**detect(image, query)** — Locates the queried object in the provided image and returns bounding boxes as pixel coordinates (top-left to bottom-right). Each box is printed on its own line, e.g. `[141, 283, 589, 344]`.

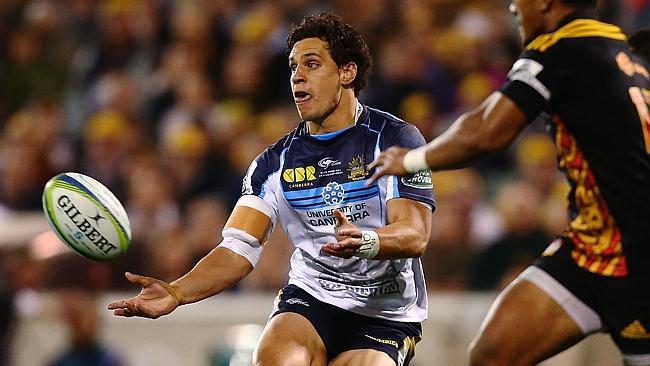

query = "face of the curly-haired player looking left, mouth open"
[289, 38, 342, 122]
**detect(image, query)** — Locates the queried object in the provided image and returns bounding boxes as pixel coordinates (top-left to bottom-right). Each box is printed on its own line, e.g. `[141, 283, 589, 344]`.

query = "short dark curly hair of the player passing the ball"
[286, 13, 373, 96]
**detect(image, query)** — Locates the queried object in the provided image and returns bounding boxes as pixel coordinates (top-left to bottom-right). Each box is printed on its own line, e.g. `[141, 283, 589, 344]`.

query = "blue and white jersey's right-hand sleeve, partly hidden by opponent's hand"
[384, 124, 436, 210]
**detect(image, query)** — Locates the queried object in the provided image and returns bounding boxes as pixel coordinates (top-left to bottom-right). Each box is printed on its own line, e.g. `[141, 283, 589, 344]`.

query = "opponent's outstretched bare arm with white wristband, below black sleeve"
[368, 92, 528, 185]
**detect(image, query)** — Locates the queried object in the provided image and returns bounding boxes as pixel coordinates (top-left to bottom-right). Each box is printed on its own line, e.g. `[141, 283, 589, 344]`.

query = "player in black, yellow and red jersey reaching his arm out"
[370, 0, 650, 366]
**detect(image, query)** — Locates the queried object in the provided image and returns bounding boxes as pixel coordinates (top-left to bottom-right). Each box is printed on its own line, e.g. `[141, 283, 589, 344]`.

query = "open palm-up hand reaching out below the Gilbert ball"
[107, 272, 180, 319]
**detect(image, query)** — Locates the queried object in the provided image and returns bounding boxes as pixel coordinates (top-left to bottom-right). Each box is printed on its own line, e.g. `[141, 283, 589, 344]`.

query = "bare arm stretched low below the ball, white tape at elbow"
[108, 206, 272, 319]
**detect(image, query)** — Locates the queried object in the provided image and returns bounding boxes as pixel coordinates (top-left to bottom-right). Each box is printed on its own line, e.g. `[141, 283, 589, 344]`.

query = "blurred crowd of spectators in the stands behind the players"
[0, 0, 650, 334]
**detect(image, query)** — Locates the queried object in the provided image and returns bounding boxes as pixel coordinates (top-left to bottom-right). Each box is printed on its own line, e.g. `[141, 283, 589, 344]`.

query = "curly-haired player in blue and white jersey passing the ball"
[108, 14, 434, 366]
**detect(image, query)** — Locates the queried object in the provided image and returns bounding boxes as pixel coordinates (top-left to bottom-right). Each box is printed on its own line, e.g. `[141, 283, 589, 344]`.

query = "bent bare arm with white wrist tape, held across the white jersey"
[321, 198, 431, 259]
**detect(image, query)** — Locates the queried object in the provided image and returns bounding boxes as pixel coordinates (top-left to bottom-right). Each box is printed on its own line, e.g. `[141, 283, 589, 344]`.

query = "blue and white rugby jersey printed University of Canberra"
[243, 103, 435, 322]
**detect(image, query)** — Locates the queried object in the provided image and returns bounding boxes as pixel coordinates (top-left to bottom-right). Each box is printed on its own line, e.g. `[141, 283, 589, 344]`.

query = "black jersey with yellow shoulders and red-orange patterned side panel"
[501, 12, 650, 277]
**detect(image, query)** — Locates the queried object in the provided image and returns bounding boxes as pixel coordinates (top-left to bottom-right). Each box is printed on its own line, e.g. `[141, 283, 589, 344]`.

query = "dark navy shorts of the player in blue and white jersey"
[271, 285, 422, 366]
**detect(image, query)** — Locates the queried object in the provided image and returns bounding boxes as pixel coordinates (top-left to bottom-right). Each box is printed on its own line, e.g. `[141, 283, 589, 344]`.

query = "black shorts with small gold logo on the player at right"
[535, 239, 650, 358]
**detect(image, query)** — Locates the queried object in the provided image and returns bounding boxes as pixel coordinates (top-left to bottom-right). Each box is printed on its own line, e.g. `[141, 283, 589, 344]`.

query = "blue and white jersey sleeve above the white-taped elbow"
[242, 150, 280, 225]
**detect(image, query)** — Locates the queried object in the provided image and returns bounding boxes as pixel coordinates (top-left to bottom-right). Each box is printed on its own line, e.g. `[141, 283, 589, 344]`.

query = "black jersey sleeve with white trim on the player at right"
[500, 45, 570, 121]
